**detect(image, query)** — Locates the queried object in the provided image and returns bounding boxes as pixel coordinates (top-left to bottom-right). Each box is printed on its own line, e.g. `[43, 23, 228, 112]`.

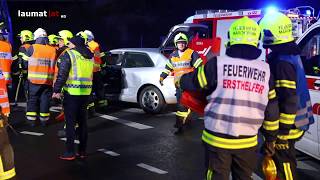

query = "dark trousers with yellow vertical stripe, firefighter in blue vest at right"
[272, 140, 298, 180]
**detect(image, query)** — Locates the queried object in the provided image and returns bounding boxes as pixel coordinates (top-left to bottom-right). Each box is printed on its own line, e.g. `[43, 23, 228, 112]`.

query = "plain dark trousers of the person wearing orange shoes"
[63, 93, 89, 153]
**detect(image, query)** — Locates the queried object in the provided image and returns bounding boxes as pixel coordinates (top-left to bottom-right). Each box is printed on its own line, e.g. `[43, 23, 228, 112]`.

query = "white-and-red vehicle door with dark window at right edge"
[297, 27, 320, 157]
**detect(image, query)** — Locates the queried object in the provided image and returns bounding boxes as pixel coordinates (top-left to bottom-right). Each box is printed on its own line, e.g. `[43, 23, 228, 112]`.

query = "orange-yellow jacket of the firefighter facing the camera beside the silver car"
[160, 48, 202, 78]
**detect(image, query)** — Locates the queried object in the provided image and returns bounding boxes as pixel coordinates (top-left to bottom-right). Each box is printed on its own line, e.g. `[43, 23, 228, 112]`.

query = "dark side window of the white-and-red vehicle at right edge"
[299, 28, 320, 76]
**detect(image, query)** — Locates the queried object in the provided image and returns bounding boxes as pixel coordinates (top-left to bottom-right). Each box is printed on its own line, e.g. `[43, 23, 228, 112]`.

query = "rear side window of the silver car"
[122, 52, 154, 68]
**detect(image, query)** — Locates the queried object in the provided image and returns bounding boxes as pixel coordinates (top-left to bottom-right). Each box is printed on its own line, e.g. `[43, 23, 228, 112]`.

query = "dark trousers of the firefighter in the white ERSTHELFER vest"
[205, 144, 258, 180]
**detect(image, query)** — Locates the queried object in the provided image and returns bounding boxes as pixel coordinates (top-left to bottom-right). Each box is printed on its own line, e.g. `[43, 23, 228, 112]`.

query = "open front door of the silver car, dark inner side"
[101, 51, 124, 94]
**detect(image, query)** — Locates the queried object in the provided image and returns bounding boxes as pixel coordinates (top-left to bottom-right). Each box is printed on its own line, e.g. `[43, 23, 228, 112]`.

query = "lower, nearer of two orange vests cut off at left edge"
[0, 71, 10, 116]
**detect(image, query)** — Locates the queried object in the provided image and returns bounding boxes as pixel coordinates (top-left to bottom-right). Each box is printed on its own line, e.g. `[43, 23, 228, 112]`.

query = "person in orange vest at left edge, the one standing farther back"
[0, 31, 13, 102]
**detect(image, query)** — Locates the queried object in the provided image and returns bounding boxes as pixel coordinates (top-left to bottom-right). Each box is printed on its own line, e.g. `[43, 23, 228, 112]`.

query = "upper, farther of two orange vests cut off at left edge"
[0, 41, 13, 84]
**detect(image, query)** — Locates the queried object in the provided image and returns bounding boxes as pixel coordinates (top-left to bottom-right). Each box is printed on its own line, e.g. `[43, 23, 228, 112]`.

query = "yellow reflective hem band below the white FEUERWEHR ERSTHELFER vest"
[202, 130, 258, 149]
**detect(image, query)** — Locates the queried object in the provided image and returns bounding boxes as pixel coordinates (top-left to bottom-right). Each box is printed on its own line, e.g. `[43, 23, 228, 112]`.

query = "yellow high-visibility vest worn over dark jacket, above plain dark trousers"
[63, 50, 94, 96]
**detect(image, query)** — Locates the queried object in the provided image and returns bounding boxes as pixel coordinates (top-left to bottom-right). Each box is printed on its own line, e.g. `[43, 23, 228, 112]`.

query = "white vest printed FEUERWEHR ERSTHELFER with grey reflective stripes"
[205, 57, 270, 137]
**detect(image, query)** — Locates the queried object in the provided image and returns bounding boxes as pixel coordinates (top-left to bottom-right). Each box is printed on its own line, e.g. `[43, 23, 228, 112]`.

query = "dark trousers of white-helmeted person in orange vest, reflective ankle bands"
[27, 83, 52, 121]
